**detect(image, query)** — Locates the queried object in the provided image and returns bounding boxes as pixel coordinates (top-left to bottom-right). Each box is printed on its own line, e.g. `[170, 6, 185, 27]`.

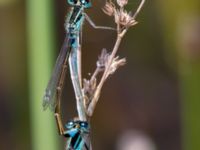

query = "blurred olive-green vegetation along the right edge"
[158, 0, 200, 150]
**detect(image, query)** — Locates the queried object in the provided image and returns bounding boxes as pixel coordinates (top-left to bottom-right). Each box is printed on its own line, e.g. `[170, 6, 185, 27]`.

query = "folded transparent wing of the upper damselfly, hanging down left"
[43, 36, 70, 110]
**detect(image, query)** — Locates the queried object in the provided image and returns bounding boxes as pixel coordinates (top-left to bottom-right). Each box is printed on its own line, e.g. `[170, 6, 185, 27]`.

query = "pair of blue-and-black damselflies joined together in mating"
[43, 0, 113, 150]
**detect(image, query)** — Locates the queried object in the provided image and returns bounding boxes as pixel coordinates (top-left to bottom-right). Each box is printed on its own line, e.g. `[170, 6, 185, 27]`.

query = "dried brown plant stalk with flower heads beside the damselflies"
[83, 0, 145, 117]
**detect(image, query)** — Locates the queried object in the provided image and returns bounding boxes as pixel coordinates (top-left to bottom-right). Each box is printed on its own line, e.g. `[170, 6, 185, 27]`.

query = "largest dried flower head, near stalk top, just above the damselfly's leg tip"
[115, 10, 137, 27]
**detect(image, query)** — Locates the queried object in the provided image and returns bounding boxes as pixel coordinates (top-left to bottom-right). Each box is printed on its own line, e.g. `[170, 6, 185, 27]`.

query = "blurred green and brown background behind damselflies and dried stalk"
[0, 0, 200, 150]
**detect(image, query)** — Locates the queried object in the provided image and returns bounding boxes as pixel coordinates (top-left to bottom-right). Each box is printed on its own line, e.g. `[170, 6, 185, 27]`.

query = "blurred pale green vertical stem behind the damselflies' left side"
[27, 0, 58, 150]
